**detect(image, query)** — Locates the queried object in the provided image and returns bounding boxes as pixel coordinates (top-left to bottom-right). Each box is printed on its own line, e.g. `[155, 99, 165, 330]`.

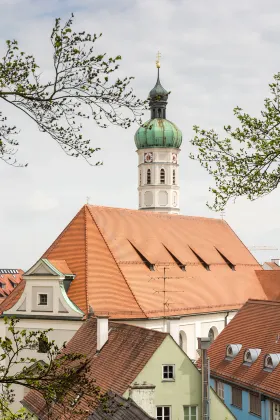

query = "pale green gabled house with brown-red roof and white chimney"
[23, 317, 235, 420]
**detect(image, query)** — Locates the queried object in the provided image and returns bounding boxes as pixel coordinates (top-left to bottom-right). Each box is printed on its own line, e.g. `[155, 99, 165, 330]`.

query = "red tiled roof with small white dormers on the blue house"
[208, 300, 280, 399]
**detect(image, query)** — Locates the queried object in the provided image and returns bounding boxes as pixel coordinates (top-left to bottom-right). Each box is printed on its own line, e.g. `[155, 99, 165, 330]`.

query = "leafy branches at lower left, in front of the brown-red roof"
[0, 318, 108, 420]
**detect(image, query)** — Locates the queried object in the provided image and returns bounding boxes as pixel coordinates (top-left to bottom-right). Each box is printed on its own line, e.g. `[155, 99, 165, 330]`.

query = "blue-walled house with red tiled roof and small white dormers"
[208, 300, 280, 420]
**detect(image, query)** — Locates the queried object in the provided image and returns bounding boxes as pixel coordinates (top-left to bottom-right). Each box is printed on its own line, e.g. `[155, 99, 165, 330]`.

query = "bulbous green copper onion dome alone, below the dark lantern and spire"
[134, 118, 182, 149]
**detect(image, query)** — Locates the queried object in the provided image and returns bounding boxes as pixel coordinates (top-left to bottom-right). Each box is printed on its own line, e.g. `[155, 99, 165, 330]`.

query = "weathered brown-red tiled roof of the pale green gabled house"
[23, 318, 167, 418]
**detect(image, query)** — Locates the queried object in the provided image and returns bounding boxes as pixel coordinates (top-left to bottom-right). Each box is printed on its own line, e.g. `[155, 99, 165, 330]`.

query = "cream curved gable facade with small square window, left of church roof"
[0, 259, 84, 411]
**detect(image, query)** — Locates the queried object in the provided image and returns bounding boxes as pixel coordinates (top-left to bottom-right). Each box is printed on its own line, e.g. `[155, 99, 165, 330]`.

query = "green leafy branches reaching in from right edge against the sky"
[191, 73, 280, 211]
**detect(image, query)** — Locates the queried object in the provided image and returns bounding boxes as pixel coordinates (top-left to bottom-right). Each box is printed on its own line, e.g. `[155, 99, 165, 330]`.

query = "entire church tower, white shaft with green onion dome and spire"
[135, 60, 182, 214]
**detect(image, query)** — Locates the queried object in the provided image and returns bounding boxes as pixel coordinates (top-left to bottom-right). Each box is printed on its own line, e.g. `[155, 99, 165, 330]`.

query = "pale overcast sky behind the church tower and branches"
[0, 0, 280, 269]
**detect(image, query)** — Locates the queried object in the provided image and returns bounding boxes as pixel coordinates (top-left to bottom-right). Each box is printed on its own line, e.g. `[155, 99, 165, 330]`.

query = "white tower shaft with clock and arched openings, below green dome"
[137, 147, 180, 214]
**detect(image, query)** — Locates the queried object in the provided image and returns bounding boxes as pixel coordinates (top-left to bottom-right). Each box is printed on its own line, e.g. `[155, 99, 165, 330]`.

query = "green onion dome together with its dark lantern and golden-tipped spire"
[134, 61, 182, 149]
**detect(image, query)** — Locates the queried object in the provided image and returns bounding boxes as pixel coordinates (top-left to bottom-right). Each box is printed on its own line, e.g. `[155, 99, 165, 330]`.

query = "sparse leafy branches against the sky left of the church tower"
[0, 15, 144, 165]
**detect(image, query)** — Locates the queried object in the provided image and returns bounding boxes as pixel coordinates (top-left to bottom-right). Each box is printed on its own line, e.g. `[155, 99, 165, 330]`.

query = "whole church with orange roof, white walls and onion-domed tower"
[0, 62, 267, 368]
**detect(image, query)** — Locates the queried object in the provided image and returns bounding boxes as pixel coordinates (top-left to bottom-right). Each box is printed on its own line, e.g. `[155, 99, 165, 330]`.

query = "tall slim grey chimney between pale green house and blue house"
[197, 337, 211, 420]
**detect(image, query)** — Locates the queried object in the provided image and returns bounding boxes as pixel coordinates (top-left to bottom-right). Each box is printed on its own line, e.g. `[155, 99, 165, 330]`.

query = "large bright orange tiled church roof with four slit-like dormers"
[44, 205, 266, 319]
